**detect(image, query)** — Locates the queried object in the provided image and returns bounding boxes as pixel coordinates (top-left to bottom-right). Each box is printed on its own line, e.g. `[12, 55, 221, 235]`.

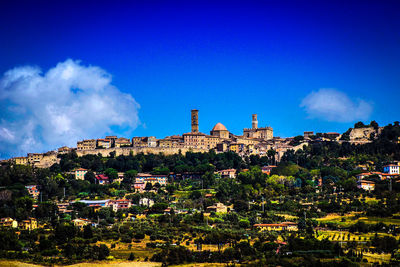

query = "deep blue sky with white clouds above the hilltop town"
[0, 0, 400, 158]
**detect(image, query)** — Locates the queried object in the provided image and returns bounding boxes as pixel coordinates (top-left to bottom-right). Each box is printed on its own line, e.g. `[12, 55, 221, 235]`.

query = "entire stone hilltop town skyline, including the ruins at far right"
[11, 109, 382, 168]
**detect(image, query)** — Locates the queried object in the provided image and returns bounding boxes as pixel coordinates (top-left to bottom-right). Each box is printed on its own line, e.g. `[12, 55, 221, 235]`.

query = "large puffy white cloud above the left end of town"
[0, 59, 139, 158]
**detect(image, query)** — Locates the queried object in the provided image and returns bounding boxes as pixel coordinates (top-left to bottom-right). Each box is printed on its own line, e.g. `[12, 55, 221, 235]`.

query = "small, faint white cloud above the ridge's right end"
[300, 88, 372, 122]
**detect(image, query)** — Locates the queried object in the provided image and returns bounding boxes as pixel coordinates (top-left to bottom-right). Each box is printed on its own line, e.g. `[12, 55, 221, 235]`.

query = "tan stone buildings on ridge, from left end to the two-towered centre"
[12, 110, 279, 168]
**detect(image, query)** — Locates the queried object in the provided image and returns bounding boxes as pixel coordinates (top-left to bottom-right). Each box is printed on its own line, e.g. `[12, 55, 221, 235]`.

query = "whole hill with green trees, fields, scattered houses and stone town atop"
[0, 110, 400, 266]
